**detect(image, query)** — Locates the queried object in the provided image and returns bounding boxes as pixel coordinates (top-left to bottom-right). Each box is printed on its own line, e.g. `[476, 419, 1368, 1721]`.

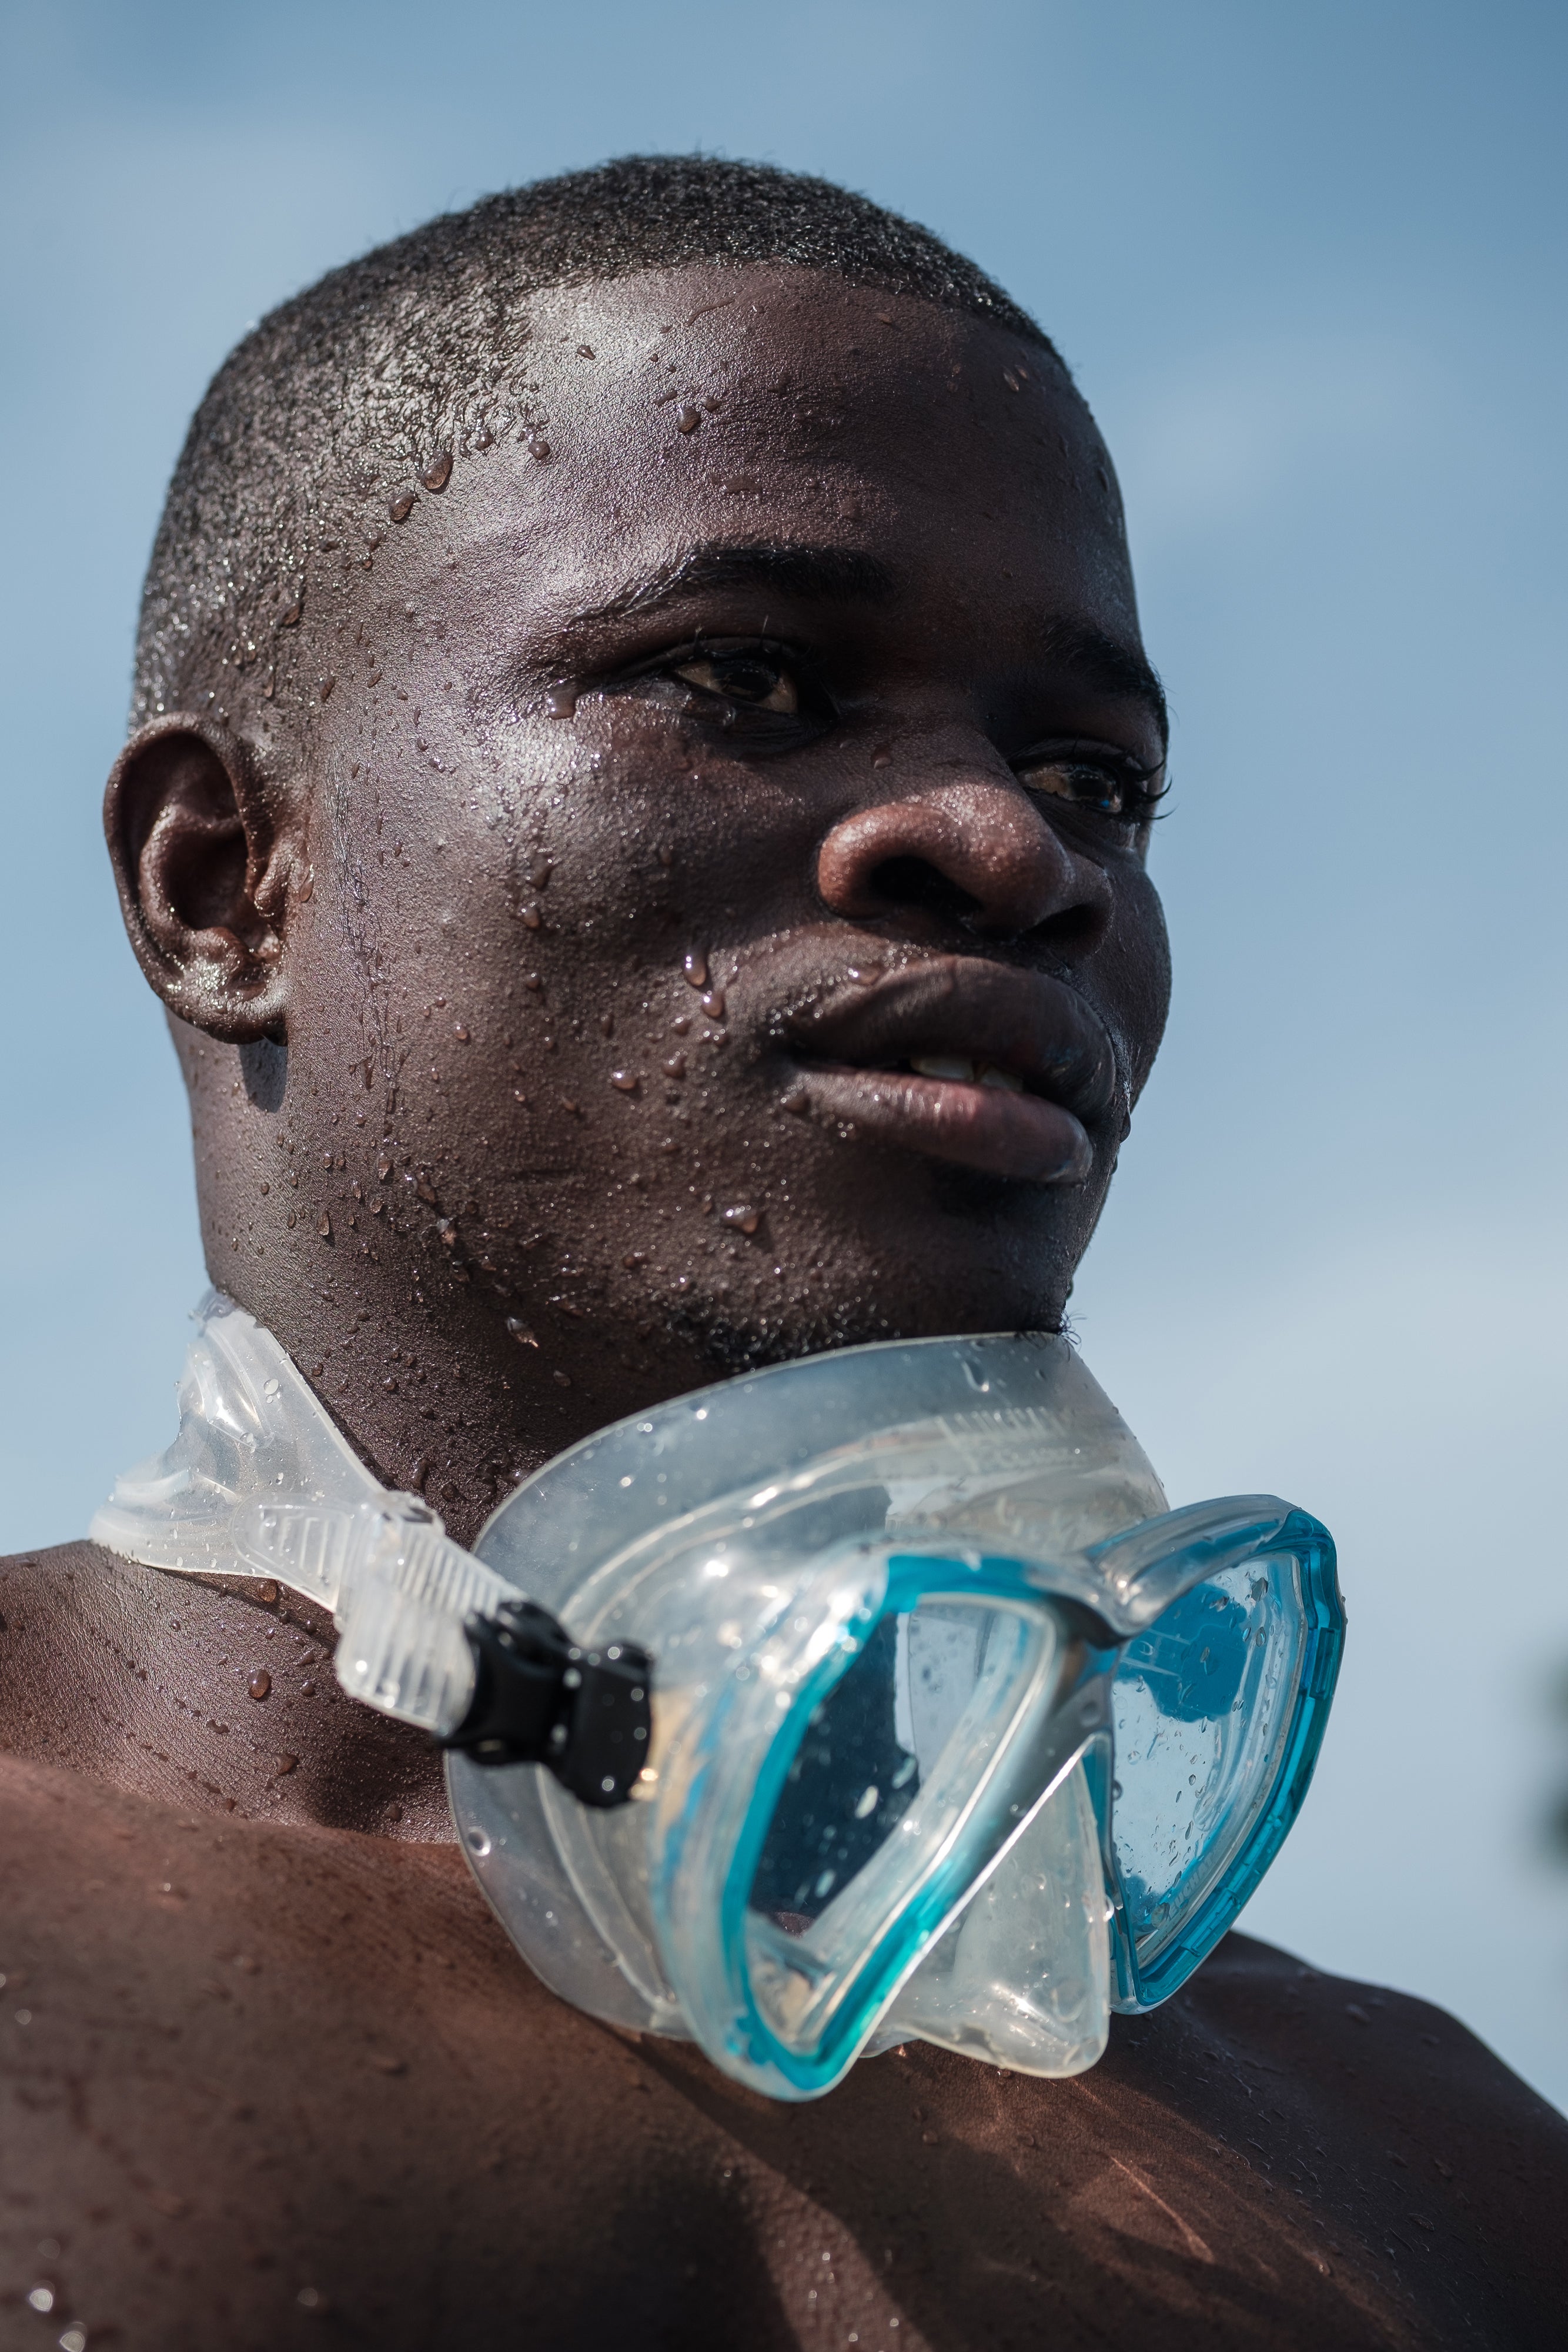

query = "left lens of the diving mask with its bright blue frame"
[654, 1557, 1102, 2098]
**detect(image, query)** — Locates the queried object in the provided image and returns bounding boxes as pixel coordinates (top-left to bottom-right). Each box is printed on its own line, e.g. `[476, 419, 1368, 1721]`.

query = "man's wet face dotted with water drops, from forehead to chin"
[289, 268, 1168, 1411]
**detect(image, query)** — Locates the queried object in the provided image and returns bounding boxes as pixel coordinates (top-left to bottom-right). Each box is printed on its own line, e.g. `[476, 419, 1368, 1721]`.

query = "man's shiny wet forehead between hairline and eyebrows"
[380, 266, 1135, 637]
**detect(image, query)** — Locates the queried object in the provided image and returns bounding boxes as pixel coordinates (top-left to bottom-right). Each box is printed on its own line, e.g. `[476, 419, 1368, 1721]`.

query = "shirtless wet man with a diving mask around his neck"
[0, 160, 1568, 2352]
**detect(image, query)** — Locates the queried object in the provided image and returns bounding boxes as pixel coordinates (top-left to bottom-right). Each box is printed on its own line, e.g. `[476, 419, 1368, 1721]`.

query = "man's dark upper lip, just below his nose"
[787, 955, 1121, 1127]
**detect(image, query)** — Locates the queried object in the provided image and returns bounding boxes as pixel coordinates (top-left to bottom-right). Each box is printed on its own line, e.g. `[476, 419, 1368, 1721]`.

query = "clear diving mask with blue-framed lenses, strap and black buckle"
[92, 1298, 1345, 2098]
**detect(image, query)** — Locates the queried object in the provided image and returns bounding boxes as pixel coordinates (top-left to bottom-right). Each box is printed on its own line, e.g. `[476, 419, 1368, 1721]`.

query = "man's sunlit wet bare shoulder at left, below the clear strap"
[0, 1757, 785, 2352]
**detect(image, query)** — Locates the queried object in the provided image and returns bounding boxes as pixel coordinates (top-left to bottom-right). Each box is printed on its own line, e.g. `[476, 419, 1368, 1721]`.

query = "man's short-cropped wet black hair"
[134, 155, 1067, 720]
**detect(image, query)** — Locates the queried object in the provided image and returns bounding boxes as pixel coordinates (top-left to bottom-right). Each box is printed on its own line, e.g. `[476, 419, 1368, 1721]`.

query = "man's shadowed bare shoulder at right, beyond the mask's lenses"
[1100, 1936, 1568, 2347]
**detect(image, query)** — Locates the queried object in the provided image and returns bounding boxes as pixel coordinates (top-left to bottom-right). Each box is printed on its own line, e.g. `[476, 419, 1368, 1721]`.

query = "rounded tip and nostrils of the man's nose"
[815, 769, 1112, 955]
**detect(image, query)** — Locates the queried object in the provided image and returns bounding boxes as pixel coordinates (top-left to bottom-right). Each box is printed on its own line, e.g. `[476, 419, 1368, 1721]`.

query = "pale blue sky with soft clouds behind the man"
[0, 0, 1568, 2103]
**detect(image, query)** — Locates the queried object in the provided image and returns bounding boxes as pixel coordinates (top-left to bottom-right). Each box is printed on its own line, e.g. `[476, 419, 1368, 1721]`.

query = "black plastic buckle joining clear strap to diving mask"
[442, 1602, 654, 1806]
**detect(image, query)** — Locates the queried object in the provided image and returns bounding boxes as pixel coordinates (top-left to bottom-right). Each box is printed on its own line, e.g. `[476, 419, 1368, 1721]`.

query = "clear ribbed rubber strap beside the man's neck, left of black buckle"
[89, 1291, 517, 1736]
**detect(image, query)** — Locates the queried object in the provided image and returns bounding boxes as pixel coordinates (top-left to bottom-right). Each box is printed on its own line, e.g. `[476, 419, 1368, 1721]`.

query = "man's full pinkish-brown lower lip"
[799, 1063, 1093, 1183]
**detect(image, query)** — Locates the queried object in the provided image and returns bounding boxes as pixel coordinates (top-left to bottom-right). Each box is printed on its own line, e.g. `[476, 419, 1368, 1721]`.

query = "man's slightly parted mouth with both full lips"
[790, 955, 1119, 1185]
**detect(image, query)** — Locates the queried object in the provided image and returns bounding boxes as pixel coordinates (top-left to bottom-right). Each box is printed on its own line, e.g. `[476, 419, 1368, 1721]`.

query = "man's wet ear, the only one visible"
[103, 713, 299, 1044]
